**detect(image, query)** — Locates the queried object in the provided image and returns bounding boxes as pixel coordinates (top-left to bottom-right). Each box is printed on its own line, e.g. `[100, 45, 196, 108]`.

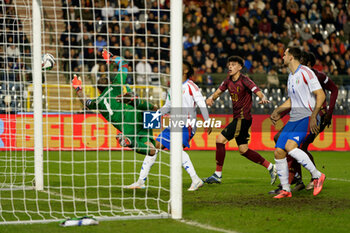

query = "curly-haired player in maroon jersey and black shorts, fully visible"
[204, 56, 277, 184]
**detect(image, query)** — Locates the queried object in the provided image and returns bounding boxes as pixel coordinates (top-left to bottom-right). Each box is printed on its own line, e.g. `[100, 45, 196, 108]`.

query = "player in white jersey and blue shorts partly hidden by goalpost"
[125, 62, 211, 191]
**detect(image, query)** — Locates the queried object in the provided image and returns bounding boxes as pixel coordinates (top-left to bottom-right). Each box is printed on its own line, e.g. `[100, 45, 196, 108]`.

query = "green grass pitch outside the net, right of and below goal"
[0, 151, 350, 233]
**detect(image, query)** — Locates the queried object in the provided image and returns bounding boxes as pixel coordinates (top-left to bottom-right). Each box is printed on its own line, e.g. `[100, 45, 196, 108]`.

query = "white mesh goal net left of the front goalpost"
[0, 0, 180, 224]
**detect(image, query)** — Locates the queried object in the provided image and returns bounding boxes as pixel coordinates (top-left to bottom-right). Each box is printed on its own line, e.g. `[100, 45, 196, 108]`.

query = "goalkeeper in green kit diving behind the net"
[72, 51, 157, 156]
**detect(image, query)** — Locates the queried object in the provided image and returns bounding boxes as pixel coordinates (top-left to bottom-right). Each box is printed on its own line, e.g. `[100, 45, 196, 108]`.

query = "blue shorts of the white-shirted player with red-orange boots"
[275, 117, 310, 150]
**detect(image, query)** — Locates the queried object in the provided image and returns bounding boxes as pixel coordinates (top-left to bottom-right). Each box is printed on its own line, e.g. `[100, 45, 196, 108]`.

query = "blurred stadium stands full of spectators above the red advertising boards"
[0, 0, 350, 114]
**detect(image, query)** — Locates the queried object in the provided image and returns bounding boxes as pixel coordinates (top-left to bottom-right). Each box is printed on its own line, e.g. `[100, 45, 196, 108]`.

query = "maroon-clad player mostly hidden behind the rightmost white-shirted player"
[269, 52, 338, 194]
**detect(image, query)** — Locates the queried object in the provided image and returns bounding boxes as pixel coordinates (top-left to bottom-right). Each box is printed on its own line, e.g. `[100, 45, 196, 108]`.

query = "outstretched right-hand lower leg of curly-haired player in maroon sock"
[238, 144, 277, 185]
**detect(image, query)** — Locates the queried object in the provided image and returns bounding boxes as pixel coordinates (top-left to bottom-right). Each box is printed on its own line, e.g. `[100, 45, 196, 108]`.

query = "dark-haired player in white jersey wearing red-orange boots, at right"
[271, 47, 326, 198]
